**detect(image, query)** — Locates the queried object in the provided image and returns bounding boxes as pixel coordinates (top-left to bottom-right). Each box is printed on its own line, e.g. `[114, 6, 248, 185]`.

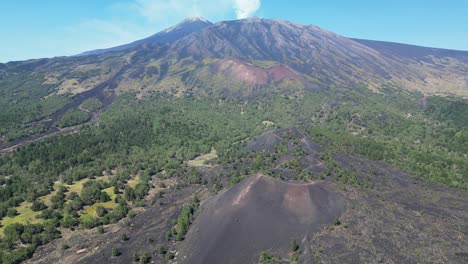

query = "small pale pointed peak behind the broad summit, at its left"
[80, 17, 212, 56]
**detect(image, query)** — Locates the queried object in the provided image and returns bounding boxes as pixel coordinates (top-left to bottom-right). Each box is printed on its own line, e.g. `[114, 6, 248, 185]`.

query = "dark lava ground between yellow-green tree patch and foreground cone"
[27, 183, 202, 264]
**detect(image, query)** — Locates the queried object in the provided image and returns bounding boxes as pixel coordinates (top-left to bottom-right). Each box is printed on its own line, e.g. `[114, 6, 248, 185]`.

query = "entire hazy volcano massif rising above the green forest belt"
[0, 17, 468, 100]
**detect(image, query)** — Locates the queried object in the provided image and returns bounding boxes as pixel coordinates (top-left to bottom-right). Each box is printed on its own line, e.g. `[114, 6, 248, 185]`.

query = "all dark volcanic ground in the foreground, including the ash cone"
[28, 129, 468, 264]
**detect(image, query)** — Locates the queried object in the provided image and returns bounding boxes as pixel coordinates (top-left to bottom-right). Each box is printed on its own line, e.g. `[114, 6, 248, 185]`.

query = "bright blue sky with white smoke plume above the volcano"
[0, 0, 468, 62]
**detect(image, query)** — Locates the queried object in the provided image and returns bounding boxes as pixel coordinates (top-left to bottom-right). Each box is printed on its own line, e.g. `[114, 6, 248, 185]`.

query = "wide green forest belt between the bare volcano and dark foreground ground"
[0, 85, 468, 263]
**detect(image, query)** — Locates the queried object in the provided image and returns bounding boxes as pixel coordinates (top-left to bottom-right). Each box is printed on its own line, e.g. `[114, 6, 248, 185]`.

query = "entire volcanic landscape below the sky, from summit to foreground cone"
[0, 18, 468, 263]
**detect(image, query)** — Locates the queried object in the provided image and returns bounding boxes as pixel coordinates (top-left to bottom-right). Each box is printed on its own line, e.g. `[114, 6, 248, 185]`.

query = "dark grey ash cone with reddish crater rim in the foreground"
[179, 175, 345, 264]
